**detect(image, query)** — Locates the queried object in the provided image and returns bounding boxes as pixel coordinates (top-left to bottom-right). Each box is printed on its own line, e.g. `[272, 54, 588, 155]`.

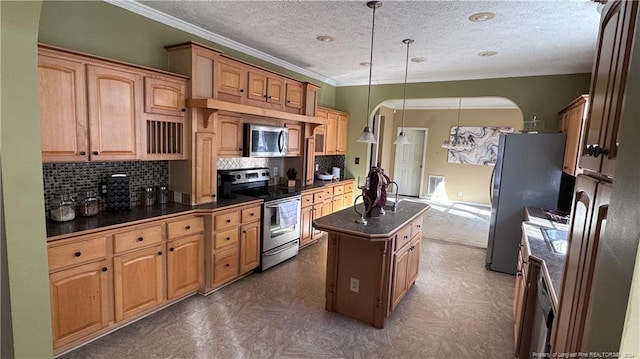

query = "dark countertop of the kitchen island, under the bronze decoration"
[313, 201, 431, 241]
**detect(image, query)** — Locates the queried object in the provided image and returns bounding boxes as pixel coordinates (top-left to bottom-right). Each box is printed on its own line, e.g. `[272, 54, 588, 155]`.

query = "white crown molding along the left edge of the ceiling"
[103, 0, 337, 86]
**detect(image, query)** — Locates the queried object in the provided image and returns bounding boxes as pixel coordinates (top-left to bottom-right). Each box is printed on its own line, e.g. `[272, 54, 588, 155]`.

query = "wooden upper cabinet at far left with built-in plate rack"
[38, 45, 186, 163]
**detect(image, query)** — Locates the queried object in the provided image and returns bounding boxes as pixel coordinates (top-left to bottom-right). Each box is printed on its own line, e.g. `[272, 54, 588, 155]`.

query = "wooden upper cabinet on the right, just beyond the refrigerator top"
[560, 95, 589, 176]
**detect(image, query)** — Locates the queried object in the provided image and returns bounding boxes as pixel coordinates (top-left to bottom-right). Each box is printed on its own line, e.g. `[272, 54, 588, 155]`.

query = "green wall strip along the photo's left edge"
[0, 1, 53, 358]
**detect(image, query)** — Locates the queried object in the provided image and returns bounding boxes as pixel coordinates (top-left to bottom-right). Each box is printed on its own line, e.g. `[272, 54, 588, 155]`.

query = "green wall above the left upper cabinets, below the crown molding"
[38, 1, 335, 107]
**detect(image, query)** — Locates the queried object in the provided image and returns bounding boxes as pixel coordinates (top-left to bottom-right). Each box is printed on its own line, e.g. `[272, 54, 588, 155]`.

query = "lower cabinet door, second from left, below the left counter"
[113, 245, 164, 322]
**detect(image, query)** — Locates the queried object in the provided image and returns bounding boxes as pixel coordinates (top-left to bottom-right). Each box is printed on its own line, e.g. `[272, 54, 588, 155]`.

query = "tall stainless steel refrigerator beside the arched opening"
[486, 133, 566, 274]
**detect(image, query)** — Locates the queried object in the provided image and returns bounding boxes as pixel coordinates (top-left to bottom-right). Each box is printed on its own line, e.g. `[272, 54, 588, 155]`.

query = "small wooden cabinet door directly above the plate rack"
[144, 77, 186, 117]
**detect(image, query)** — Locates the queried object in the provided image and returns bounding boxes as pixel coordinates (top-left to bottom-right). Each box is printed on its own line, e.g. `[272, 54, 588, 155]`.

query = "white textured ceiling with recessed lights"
[120, 0, 600, 86]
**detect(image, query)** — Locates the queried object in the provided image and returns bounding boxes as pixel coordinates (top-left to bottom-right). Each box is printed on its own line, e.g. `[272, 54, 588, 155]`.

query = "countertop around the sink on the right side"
[522, 207, 569, 313]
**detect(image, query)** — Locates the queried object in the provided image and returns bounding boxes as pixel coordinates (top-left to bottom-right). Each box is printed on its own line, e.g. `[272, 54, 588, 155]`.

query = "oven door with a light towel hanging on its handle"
[262, 196, 300, 252]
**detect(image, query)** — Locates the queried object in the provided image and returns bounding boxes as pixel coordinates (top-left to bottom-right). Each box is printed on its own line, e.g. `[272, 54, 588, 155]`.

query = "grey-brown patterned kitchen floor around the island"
[62, 204, 514, 359]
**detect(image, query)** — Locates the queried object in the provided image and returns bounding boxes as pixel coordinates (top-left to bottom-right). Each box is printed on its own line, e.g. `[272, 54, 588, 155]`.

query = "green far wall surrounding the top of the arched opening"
[336, 74, 591, 177]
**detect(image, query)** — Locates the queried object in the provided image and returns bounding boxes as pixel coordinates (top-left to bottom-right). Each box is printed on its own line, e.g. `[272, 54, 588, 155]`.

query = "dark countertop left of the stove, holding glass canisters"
[46, 195, 262, 241]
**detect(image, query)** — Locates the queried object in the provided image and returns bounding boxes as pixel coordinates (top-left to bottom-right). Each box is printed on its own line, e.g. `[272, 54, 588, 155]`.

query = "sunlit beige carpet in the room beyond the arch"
[402, 197, 491, 248]
